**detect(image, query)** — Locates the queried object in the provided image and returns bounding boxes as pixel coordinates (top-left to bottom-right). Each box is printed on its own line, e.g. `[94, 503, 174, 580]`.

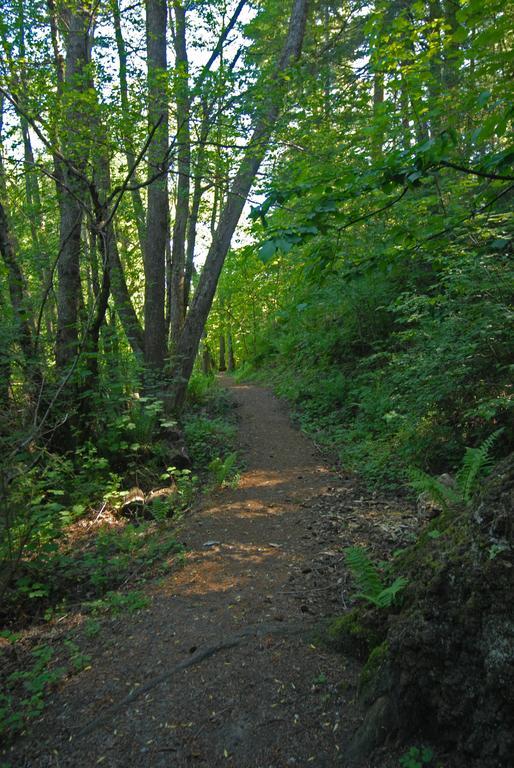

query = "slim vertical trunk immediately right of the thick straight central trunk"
[170, 2, 191, 344]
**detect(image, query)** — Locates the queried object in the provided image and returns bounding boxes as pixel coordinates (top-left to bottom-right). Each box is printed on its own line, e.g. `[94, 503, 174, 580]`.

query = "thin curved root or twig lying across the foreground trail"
[70, 621, 322, 739]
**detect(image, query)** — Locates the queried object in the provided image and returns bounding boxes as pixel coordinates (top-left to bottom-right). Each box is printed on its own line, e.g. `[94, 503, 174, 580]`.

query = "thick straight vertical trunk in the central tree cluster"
[145, 0, 168, 371]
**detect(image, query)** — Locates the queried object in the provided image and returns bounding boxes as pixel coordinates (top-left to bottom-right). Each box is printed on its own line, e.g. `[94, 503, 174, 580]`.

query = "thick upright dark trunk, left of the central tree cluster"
[56, 4, 92, 368]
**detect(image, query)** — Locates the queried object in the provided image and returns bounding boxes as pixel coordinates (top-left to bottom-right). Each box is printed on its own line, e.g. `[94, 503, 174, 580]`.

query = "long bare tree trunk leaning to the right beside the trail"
[169, 0, 309, 410]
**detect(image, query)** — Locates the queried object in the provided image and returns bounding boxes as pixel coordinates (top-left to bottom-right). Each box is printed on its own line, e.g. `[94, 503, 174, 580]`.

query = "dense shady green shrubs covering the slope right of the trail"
[234, 243, 514, 493]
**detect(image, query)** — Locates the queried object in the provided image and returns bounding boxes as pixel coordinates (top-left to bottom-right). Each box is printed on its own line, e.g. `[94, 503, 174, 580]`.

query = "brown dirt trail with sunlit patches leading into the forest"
[6, 379, 368, 768]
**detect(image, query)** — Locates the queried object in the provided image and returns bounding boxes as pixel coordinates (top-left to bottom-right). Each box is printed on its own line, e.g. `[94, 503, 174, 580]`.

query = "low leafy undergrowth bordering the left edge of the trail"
[0, 373, 237, 741]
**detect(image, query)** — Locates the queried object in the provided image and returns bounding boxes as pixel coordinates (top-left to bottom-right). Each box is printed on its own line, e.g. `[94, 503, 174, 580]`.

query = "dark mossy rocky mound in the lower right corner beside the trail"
[346, 457, 514, 768]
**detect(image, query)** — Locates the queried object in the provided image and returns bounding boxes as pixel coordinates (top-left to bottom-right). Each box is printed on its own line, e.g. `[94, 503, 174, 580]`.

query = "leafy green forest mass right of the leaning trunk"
[204, 2, 513, 484]
